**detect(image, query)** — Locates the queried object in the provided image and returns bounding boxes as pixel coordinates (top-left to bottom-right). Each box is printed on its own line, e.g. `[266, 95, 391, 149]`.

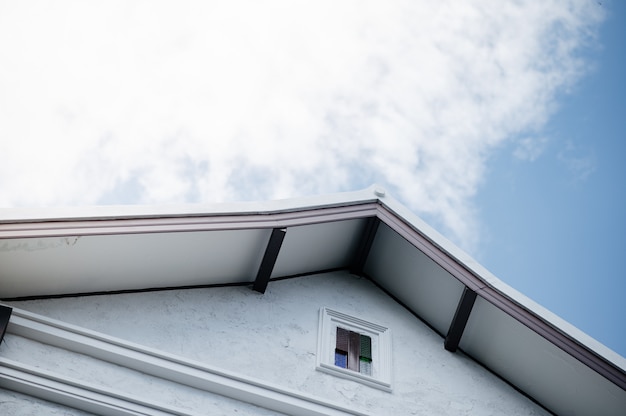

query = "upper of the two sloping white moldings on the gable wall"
[0, 308, 367, 416]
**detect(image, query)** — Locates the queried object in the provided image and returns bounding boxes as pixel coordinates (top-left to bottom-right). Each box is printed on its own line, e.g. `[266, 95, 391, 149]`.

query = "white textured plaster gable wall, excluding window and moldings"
[0, 272, 548, 415]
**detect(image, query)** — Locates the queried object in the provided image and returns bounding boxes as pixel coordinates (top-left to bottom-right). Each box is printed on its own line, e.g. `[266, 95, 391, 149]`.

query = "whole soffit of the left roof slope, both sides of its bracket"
[0, 213, 365, 299]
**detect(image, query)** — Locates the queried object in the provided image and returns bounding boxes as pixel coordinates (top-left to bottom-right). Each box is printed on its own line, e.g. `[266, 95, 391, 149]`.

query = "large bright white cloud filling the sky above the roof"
[0, 0, 601, 247]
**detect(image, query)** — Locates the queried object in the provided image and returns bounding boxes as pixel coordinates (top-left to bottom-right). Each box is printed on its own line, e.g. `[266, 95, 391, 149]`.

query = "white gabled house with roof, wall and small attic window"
[0, 186, 626, 415]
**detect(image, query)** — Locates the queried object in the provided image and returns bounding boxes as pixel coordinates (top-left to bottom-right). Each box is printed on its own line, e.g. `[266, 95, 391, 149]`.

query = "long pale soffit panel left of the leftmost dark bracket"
[0, 229, 270, 298]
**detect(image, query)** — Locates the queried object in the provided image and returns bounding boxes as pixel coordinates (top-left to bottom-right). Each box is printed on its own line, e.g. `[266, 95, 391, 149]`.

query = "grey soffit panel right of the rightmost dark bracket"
[460, 297, 626, 415]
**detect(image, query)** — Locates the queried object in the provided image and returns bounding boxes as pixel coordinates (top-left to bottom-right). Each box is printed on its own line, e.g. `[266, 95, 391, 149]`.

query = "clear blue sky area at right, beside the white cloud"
[476, 1, 626, 356]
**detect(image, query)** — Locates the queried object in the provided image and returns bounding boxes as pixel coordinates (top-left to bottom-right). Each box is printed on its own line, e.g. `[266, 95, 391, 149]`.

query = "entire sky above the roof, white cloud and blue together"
[0, 0, 626, 356]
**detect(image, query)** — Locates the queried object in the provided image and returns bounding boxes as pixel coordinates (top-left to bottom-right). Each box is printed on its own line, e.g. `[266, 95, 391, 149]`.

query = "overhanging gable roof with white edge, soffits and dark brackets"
[0, 185, 626, 414]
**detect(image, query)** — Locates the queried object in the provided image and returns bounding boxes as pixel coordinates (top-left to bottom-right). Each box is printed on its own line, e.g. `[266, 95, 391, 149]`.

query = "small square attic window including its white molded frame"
[317, 308, 391, 391]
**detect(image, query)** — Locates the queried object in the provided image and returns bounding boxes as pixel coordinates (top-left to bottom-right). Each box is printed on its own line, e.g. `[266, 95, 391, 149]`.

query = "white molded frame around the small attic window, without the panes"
[317, 308, 391, 391]
